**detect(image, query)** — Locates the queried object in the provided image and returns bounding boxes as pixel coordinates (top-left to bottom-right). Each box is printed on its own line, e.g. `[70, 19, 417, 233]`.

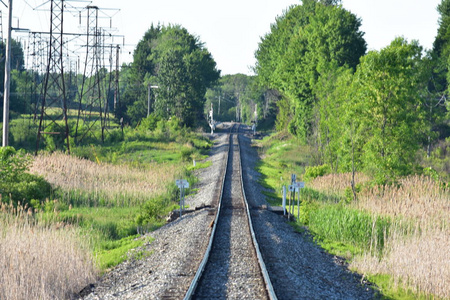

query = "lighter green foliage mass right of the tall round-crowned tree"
[315, 38, 428, 184]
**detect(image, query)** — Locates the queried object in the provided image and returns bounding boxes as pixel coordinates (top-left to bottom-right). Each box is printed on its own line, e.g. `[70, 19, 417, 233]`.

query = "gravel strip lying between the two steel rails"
[193, 135, 268, 299]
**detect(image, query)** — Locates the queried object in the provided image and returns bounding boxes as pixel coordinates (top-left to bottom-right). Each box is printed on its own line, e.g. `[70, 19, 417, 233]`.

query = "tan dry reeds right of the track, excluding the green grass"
[352, 176, 450, 298]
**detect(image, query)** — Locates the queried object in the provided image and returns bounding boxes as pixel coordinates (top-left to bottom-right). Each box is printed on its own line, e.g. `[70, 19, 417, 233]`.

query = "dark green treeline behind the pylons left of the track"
[0, 25, 220, 134]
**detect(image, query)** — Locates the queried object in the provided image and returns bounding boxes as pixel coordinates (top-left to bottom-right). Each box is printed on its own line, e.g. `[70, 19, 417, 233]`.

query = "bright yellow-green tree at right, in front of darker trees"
[349, 38, 427, 183]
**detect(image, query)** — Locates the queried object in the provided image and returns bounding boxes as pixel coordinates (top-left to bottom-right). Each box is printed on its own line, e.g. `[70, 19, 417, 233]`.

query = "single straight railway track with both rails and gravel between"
[184, 124, 276, 299]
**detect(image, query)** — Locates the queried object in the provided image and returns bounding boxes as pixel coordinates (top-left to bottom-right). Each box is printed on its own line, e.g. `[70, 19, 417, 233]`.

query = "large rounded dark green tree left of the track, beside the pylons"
[120, 25, 220, 126]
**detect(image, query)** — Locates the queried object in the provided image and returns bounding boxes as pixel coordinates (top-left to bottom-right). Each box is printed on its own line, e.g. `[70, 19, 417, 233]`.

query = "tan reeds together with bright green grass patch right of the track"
[309, 174, 450, 298]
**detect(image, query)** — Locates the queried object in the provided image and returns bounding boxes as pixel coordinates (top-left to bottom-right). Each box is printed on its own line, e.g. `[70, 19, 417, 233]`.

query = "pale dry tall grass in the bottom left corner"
[0, 204, 96, 300]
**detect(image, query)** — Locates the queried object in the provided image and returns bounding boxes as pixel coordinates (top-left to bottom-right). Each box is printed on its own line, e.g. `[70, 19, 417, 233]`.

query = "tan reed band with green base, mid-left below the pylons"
[30, 152, 181, 206]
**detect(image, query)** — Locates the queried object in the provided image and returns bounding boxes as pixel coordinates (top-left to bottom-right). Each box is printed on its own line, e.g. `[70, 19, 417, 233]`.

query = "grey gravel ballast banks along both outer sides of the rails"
[80, 124, 374, 300]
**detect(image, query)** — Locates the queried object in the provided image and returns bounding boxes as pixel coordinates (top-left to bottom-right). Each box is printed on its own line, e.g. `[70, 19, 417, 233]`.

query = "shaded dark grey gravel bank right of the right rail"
[241, 128, 377, 299]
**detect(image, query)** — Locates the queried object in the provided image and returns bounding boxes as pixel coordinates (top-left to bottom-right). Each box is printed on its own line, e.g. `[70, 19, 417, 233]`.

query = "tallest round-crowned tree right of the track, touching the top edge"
[255, 0, 366, 141]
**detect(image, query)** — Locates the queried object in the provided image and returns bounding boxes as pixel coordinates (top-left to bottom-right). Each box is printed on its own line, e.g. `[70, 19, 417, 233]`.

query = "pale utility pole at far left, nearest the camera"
[2, 0, 12, 147]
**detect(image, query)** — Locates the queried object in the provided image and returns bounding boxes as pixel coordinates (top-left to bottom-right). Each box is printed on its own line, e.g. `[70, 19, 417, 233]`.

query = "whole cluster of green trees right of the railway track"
[255, 0, 450, 183]
